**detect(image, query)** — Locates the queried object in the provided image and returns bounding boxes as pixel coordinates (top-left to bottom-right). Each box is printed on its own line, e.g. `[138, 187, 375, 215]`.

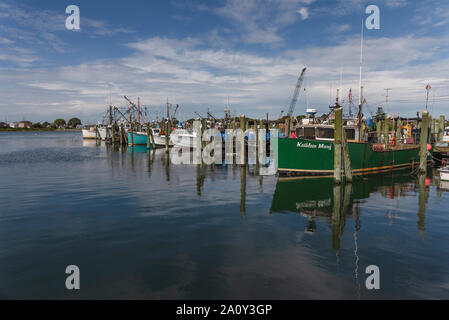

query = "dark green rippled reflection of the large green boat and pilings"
[270, 172, 429, 246]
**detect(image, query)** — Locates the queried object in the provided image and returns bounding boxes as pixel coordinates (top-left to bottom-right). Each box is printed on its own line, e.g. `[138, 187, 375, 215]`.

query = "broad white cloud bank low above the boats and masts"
[0, 32, 449, 120]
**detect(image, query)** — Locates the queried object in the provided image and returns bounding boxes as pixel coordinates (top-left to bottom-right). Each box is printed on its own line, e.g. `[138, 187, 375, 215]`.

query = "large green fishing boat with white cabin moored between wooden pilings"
[278, 124, 430, 175]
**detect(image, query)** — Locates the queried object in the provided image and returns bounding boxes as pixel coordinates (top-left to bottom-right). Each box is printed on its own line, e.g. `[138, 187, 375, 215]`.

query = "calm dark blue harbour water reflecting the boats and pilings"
[0, 133, 449, 299]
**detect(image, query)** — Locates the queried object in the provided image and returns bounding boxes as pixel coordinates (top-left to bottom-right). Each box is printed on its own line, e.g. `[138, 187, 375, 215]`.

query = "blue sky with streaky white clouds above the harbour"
[0, 0, 449, 123]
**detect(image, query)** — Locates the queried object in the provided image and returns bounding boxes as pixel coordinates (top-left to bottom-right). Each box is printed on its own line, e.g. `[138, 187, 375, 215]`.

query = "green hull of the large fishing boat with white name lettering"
[278, 139, 426, 175]
